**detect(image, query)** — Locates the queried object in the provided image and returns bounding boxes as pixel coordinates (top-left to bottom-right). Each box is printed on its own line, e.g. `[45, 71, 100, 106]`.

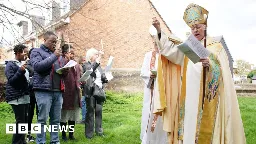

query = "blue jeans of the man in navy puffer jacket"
[35, 91, 63, 144]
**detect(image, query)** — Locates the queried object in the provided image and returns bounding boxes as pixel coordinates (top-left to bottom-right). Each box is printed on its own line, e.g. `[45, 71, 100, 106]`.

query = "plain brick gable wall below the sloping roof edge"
[56, 0, 170, 69]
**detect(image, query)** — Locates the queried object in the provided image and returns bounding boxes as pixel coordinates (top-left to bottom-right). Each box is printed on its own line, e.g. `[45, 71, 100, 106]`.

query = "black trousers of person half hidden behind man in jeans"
[28, 92, 38, 134]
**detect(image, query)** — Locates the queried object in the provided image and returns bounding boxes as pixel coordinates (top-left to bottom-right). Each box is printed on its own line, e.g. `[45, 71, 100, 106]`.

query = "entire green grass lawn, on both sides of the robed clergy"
[0, 92, 256, 144]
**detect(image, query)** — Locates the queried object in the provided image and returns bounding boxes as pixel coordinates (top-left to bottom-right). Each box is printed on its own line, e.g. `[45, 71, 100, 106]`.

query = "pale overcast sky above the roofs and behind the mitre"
[0, 0, 256, 65]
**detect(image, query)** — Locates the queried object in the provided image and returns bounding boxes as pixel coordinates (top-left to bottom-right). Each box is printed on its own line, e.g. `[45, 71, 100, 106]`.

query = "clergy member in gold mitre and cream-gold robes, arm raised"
[153, 4, 246, 144]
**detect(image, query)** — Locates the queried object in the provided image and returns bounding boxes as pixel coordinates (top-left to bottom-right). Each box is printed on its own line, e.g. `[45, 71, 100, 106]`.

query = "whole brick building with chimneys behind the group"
[16, 0, 171, 70]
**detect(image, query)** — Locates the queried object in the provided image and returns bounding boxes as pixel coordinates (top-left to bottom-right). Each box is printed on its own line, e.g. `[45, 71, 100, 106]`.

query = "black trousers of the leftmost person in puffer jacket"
[11, 104, 28, 144]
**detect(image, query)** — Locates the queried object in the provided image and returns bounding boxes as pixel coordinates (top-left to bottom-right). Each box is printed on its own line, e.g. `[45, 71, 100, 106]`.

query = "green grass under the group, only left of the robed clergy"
[0, 92, 142, 144]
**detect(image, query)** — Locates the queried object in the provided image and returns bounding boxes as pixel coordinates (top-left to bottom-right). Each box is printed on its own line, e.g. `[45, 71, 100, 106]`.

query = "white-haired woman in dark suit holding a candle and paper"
[83, 48, 108, 139]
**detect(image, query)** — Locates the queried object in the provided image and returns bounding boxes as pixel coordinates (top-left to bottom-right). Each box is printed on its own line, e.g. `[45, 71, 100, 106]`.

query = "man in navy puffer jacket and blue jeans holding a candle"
[30, 31, 68, 144]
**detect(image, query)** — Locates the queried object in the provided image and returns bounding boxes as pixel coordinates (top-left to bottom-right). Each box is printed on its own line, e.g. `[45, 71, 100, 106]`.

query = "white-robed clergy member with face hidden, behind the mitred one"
[140, 36, 167, 144]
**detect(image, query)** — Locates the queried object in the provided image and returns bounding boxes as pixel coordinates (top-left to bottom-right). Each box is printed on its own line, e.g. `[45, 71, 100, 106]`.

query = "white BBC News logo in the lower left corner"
[6, 123, 75, 134]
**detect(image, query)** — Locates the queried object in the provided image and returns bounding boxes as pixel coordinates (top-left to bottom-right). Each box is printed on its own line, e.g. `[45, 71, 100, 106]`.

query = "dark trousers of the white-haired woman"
[85, 96, 103, 138]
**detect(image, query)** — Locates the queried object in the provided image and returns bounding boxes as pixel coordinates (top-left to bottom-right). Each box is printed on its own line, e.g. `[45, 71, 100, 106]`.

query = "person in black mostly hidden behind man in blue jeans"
[26, 48, 38, 142]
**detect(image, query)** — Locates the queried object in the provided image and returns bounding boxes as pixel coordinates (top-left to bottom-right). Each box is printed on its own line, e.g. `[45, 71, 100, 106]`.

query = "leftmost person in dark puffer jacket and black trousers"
[5, 44, 30, 144]
